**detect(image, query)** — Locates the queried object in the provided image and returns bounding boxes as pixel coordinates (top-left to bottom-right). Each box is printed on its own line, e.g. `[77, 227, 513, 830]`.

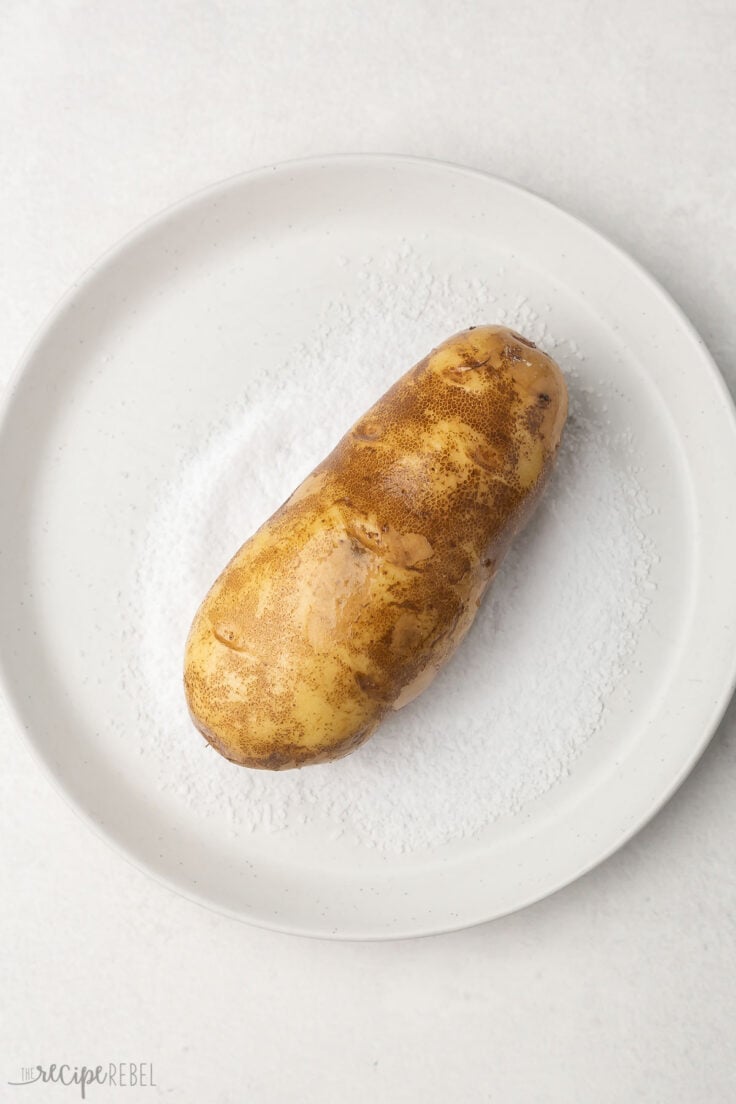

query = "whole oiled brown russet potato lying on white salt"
[184, 326, 567, 771]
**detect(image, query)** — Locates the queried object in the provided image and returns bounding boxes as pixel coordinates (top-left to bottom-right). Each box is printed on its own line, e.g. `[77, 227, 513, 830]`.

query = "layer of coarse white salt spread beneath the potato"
[122, 248, 655, 852]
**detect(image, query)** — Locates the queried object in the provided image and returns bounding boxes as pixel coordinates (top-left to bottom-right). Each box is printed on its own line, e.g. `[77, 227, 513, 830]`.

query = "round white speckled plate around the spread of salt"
[0, 157, 736, 938]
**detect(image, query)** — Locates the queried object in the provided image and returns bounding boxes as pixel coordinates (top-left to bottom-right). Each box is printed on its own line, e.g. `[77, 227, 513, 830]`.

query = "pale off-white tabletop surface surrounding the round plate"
[0, 2, 736, 1104]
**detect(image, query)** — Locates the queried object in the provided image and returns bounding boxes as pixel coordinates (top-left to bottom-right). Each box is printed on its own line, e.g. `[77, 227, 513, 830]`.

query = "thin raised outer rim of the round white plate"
[0, 152, 736, 942]
